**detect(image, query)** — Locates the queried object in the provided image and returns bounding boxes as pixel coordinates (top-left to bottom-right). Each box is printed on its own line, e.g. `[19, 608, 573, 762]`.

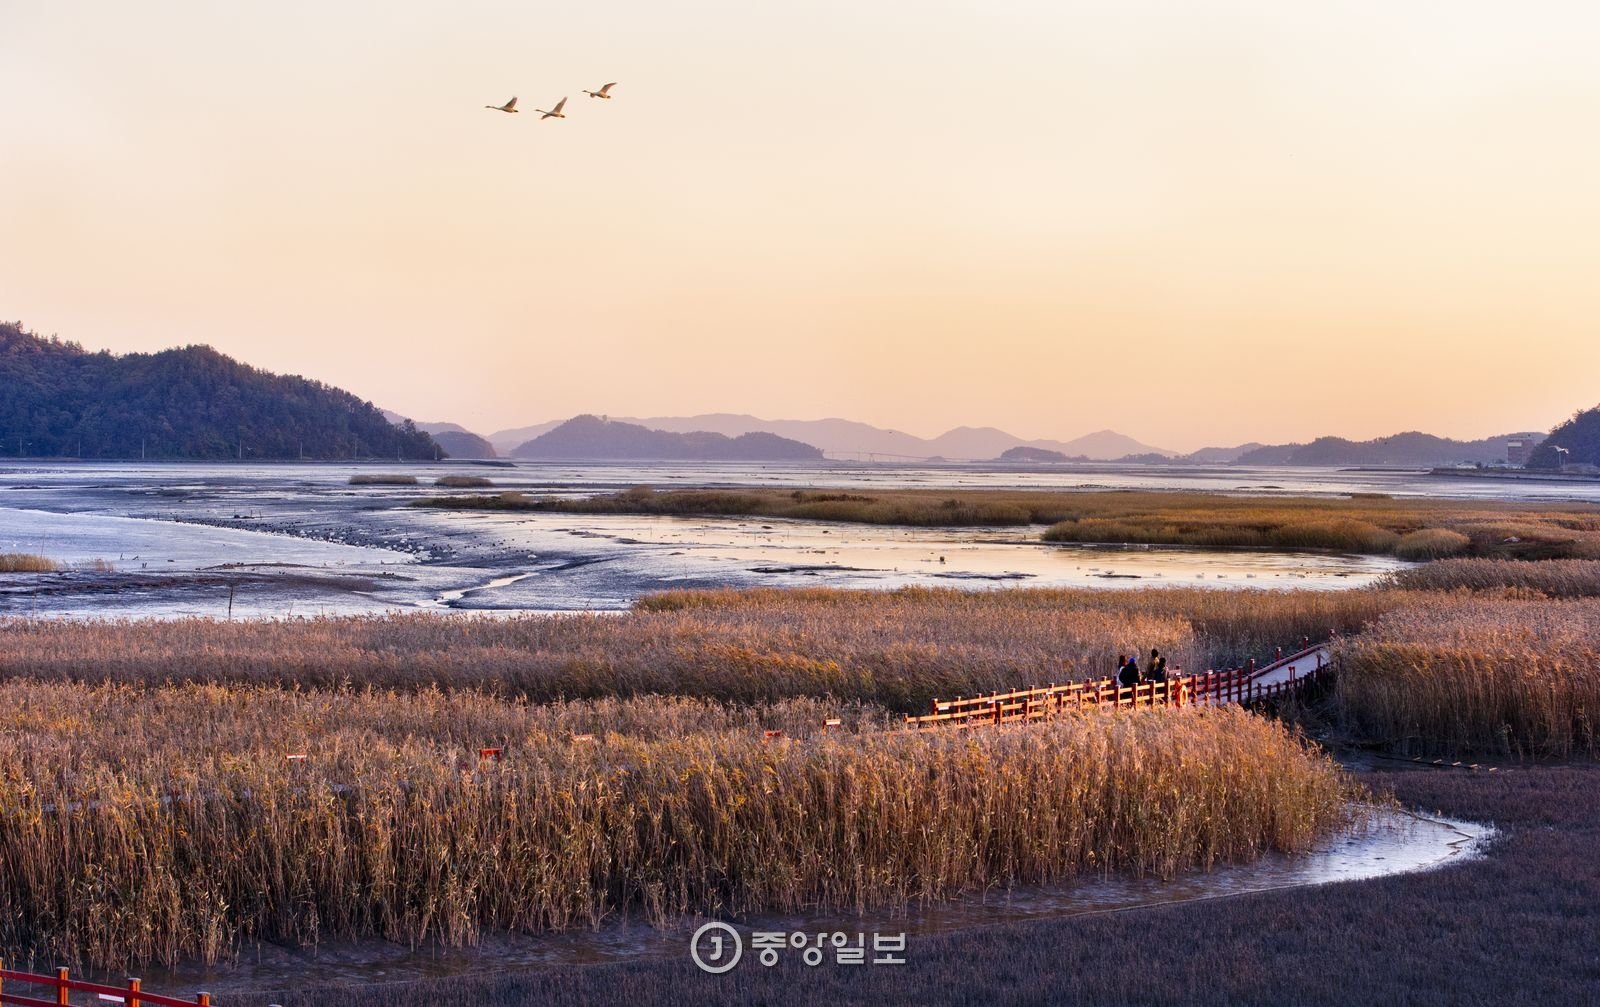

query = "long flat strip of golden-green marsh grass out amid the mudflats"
[414, 487, 1600, 560]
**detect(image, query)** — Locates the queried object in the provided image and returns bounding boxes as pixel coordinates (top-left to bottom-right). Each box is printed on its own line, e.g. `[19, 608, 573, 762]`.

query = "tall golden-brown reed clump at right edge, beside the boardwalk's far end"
[1338, 594, 1600, 759]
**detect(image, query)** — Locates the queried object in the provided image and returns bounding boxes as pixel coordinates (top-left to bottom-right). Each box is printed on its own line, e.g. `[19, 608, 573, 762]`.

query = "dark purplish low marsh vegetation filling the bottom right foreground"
[226, 765, 1600, 1007]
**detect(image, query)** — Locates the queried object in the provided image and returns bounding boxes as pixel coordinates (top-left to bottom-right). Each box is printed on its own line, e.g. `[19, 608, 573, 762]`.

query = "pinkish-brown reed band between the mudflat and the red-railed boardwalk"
[0, 588, 1405, 712]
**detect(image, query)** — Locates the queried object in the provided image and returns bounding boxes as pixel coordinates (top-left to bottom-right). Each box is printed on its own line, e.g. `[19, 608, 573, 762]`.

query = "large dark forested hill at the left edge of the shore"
[0, 323, 438, 461]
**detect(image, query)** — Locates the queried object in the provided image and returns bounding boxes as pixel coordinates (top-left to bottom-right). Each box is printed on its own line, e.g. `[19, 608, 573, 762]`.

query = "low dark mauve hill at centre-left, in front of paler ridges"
[510, 416, 822, 461]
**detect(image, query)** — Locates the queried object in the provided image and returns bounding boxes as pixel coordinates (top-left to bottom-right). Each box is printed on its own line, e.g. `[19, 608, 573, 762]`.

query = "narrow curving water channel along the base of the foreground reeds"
[104, 810, 1493, 994]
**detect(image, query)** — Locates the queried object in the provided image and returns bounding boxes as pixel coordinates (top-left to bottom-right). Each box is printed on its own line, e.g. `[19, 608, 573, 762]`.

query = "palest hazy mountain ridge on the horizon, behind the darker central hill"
[488, 413, 1176, 461]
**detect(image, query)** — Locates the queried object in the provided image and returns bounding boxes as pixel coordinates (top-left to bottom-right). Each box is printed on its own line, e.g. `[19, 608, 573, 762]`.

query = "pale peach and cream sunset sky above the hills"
[0, 0, 1600, 451]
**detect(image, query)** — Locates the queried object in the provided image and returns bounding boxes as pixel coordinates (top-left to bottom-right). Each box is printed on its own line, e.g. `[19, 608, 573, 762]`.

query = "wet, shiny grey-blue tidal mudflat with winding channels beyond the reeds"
[0, 464, 1403, 618]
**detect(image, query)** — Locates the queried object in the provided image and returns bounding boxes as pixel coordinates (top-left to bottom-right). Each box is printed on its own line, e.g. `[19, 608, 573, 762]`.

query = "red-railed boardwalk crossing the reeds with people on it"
[906, 645, 1326, 728]
